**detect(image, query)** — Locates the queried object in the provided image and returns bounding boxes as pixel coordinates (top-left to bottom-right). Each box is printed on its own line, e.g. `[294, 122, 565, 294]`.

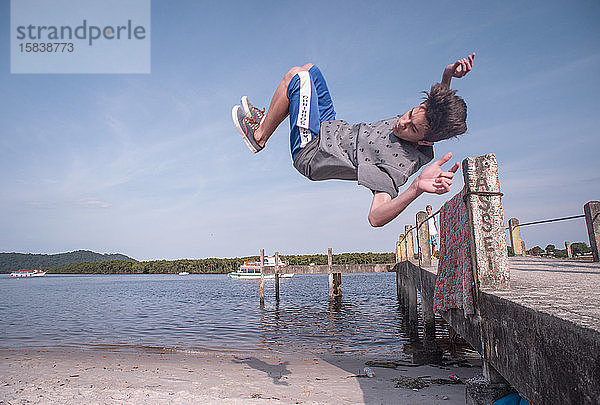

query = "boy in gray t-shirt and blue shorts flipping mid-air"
[232, 53, 475, 227]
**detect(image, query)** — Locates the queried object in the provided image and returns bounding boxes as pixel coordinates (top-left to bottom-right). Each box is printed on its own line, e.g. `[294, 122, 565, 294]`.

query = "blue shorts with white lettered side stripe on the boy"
[287, 65, 335, 159]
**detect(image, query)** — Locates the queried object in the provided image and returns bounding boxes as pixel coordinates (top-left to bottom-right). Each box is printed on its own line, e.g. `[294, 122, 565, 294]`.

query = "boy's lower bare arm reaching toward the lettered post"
[369, 153, 458, 227]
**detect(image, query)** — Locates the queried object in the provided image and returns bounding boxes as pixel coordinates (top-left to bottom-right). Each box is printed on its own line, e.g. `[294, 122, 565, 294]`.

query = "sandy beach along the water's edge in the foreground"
[0, 349, 481, 404]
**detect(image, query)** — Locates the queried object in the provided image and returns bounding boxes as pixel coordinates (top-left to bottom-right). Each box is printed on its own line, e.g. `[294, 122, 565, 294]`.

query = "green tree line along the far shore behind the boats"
[46, 252, 395, 274]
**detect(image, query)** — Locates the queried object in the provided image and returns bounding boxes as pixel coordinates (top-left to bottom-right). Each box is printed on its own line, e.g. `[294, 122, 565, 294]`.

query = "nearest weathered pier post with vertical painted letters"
[462, 153, 508, 289]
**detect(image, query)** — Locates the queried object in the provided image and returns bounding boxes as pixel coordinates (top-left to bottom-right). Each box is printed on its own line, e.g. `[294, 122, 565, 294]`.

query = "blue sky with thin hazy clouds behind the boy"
[0, 0, 600, 260]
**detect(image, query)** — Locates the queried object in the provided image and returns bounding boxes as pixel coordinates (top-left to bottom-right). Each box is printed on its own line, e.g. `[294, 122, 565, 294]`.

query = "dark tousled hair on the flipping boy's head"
[423, 83, 467, 142]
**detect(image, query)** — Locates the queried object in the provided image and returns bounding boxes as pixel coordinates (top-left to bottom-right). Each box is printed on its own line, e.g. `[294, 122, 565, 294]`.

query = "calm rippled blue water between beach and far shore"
[0, 273, 454, 354]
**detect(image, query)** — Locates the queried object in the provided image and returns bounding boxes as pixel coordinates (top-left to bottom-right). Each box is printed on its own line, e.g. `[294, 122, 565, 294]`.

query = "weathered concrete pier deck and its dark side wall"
[398, 257, 600, 404]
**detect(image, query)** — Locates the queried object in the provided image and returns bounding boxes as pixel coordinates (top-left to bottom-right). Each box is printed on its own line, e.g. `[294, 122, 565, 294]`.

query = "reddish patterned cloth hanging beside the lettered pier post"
[433, 188, 475, 315]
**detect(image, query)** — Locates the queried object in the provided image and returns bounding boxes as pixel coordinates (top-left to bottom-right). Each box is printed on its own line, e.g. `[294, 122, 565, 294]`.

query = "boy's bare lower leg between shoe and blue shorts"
[254, 63, 313, 147]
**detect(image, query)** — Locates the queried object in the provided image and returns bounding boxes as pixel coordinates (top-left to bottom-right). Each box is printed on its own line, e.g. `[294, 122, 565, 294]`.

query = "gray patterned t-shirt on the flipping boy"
[294, 116, 433, 198]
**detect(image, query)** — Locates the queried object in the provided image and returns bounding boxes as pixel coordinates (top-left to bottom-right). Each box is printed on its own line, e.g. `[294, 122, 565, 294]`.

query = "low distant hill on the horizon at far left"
[0, 250, 136, 273]
